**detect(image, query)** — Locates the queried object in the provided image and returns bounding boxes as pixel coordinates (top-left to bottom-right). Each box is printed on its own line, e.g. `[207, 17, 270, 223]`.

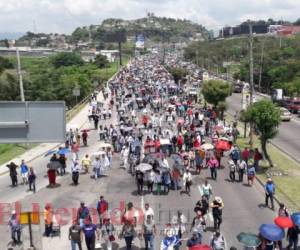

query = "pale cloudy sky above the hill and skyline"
[0, 0, 300, 33]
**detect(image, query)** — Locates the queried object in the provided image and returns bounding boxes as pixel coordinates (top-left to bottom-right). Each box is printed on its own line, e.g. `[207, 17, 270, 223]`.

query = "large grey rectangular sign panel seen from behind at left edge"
[0, 101, 66, 143]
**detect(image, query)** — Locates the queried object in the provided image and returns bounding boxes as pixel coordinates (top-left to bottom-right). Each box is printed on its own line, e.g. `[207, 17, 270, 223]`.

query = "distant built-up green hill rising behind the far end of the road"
[71, 13, 208, 43]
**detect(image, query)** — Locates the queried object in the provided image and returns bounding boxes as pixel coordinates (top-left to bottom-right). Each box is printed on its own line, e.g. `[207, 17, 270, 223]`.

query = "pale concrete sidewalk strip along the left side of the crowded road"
[0, 92, 109, 176]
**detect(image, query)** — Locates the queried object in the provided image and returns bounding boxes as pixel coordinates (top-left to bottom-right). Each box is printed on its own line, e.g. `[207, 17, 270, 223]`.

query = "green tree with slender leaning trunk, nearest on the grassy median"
[245, 100, 281, 167]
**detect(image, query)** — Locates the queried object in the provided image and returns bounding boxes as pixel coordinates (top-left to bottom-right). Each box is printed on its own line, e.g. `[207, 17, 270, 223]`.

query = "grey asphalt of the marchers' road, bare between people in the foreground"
[0, 95, 275, 250]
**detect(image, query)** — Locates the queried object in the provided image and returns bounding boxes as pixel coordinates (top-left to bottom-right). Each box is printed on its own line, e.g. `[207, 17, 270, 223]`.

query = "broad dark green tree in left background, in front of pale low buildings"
[51, 52, 84, 68]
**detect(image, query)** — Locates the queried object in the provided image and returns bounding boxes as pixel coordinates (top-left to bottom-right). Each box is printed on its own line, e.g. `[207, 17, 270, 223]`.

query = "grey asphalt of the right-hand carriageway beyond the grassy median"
[227, 93, 300, 162]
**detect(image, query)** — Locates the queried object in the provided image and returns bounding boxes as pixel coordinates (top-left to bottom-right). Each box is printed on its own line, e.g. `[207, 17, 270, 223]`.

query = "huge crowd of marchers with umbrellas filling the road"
[8, 55, 299, 250]
